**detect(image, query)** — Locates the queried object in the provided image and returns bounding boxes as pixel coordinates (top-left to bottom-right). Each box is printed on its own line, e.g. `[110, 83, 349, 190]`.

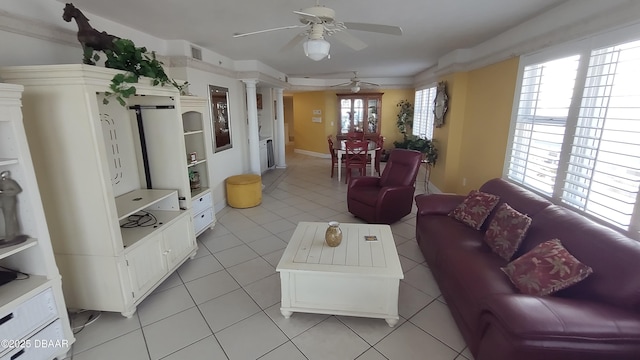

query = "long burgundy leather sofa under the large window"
[415, 179, 640, 360]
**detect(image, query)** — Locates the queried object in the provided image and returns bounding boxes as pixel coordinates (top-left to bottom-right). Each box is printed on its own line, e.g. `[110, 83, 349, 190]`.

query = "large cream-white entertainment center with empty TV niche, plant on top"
[0, 64, 208, 317]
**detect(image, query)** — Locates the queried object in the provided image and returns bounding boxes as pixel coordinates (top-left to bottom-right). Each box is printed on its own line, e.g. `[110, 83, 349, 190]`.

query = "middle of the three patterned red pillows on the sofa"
[484, 203, 531, 260]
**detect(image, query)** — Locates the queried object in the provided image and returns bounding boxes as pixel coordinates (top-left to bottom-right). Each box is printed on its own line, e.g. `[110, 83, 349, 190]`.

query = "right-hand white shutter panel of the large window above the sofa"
[562, 41, 640, 231]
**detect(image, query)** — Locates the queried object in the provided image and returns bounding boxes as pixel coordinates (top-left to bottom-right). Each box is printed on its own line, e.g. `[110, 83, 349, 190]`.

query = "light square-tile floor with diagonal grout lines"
[63, 153, 472, 360]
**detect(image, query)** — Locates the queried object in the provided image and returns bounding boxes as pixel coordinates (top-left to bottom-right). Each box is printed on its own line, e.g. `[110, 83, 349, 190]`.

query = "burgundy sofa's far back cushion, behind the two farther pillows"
[479, 178, 552, 231]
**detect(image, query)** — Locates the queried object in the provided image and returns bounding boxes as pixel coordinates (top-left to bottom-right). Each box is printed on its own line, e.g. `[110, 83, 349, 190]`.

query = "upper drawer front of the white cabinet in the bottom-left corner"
[0, 288, 58, 346]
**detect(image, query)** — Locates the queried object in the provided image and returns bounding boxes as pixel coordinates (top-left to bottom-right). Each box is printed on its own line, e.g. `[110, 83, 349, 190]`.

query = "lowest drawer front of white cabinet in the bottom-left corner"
[0, 319, 70, 360]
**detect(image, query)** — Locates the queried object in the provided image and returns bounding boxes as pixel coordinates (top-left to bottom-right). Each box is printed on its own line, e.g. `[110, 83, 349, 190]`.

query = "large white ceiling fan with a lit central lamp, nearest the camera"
[233, 3, 402, 61]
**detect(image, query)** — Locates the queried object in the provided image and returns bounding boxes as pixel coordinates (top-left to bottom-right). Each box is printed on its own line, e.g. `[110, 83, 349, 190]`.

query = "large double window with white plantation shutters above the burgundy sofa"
[505, 33, 640, 239]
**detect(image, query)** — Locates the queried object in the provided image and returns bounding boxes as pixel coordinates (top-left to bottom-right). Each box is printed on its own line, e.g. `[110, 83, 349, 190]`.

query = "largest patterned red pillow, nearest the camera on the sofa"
[501, 239, 593, 296]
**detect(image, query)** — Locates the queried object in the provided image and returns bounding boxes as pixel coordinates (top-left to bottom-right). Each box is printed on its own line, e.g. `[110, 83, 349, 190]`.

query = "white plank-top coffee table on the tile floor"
[276, 222, 404, 327]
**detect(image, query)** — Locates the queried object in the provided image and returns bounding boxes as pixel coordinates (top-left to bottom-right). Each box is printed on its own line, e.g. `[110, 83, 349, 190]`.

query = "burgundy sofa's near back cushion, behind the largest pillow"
[514, 205, 640, 311]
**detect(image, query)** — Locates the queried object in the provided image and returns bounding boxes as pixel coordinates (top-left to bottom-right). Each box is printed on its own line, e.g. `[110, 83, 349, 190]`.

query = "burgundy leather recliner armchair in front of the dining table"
[347, 149, 422, 224]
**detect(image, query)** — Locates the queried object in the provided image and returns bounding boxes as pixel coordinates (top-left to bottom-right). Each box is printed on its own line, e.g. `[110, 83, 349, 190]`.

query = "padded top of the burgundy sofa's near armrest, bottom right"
[480, 294, 640, 344]
